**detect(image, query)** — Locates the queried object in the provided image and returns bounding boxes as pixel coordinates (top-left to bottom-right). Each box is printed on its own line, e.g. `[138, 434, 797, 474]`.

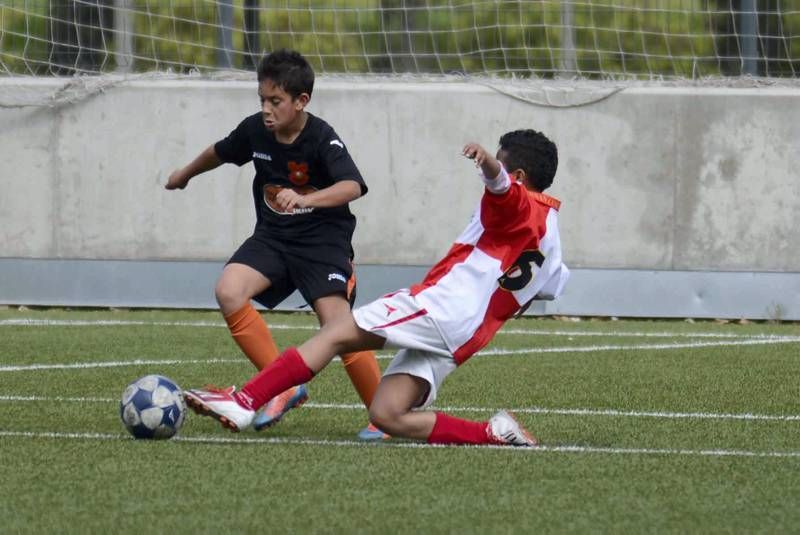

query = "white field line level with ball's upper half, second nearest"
[0, 395, 800, 422]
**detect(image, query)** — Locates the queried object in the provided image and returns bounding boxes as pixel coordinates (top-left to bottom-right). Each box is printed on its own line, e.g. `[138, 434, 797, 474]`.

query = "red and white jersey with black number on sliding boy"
[411, 171, 569, 364]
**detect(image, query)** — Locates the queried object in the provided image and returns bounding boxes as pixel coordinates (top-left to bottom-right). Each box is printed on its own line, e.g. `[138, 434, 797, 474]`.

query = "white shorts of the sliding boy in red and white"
[353, 290, 457, 407]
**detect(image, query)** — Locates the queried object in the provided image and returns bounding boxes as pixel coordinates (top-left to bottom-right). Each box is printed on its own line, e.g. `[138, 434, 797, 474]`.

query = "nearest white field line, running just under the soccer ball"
[0, 430, 800, 458]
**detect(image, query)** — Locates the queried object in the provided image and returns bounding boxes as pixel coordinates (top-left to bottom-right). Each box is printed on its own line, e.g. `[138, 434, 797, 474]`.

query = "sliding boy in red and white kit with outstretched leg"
[184, 130, 569, 446]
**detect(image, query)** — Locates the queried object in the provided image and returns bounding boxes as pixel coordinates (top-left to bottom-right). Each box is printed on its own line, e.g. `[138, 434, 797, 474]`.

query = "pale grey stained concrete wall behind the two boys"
[0, 79, 800, 316]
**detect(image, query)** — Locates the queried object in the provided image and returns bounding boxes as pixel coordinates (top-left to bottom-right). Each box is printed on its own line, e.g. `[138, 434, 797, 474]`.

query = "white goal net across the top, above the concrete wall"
[0, 0, 800, 105]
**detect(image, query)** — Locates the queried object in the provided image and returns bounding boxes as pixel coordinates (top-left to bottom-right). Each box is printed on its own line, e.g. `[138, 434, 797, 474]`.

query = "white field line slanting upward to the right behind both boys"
[0, 336, 800, 373]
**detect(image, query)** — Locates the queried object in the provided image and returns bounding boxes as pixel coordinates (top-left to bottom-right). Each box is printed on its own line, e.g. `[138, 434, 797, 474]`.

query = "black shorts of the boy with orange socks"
[228, 235, 356, 308]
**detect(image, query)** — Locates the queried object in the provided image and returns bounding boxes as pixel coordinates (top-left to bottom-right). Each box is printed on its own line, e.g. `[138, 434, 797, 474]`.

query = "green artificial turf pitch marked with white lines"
[0, 309, 800, 533]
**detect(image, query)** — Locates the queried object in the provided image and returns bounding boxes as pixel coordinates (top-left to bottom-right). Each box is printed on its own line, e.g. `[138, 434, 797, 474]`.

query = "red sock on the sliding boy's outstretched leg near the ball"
[234, 347, 314, 410]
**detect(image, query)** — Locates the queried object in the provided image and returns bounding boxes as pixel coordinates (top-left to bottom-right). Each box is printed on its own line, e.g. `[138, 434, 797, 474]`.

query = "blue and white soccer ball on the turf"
[119, 375, 186, 439]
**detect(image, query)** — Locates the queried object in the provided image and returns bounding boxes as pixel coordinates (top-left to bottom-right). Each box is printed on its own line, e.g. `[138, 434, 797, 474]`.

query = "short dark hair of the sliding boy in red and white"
[500, 129, 558, 191]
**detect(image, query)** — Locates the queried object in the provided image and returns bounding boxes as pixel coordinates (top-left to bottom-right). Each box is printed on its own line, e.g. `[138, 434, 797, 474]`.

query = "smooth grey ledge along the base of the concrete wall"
[0, 258, 800, 321]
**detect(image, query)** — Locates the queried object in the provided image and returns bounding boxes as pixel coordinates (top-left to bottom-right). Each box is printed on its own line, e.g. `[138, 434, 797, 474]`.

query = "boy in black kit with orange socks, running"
[166, 50, 386, 439]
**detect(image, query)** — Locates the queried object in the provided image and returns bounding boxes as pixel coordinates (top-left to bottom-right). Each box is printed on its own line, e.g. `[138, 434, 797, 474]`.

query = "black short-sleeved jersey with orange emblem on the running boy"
[214, 113, 367, 249]
